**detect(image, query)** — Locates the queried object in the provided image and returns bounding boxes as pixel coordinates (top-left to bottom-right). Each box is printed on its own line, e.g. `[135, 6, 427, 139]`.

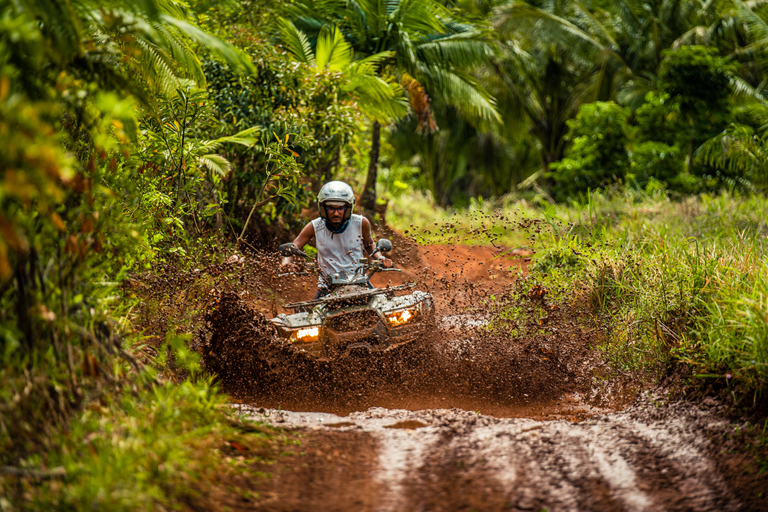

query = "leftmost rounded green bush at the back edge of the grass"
[547, 102, 629, 199]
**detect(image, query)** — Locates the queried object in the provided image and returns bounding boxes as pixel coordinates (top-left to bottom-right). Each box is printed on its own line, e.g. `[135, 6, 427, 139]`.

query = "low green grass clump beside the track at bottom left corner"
[0, 380, 288, 511]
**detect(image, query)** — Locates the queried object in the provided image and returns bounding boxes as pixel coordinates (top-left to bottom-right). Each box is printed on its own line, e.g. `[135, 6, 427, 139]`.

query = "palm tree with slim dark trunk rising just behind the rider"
[286, 0, 500, 213]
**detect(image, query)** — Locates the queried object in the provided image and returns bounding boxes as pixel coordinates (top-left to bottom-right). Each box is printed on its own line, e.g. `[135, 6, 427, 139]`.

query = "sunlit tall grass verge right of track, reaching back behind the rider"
[389, 190, 768, 399]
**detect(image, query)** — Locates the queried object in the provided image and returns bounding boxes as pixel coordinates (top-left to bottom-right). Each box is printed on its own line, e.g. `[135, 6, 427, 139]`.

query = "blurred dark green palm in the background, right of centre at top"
[492, 0, 624, 180]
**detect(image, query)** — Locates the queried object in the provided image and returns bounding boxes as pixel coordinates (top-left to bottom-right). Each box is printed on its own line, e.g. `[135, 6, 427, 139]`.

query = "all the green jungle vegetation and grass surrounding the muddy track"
[0, 0, 768, 509]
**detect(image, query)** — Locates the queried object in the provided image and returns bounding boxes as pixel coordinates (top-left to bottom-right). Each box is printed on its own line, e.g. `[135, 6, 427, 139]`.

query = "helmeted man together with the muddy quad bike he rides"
[271, 181, 432, 359]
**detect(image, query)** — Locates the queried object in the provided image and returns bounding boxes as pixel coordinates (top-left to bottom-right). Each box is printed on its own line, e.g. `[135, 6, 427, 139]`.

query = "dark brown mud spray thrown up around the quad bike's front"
[200, 262, 632, 419]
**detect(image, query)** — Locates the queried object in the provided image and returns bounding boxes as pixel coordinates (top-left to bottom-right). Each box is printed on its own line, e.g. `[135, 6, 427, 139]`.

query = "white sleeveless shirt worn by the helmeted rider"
[312, 214, 363, 284]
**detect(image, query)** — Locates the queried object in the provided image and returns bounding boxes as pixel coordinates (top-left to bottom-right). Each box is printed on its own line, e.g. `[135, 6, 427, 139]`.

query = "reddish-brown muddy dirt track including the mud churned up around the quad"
[202, 238, 768, 511]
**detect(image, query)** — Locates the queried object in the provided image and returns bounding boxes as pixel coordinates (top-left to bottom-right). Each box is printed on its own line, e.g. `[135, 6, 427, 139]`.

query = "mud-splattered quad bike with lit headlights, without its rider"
[270, 239, 433, 360]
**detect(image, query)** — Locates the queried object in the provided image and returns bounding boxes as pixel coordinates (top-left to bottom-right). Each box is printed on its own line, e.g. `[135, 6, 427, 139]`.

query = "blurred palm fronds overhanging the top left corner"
[7, 0, 253, 103]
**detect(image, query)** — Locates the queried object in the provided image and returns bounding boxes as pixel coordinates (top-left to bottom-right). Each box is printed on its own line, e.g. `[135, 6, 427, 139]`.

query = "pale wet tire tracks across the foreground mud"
[248, 398, 745, 512]
